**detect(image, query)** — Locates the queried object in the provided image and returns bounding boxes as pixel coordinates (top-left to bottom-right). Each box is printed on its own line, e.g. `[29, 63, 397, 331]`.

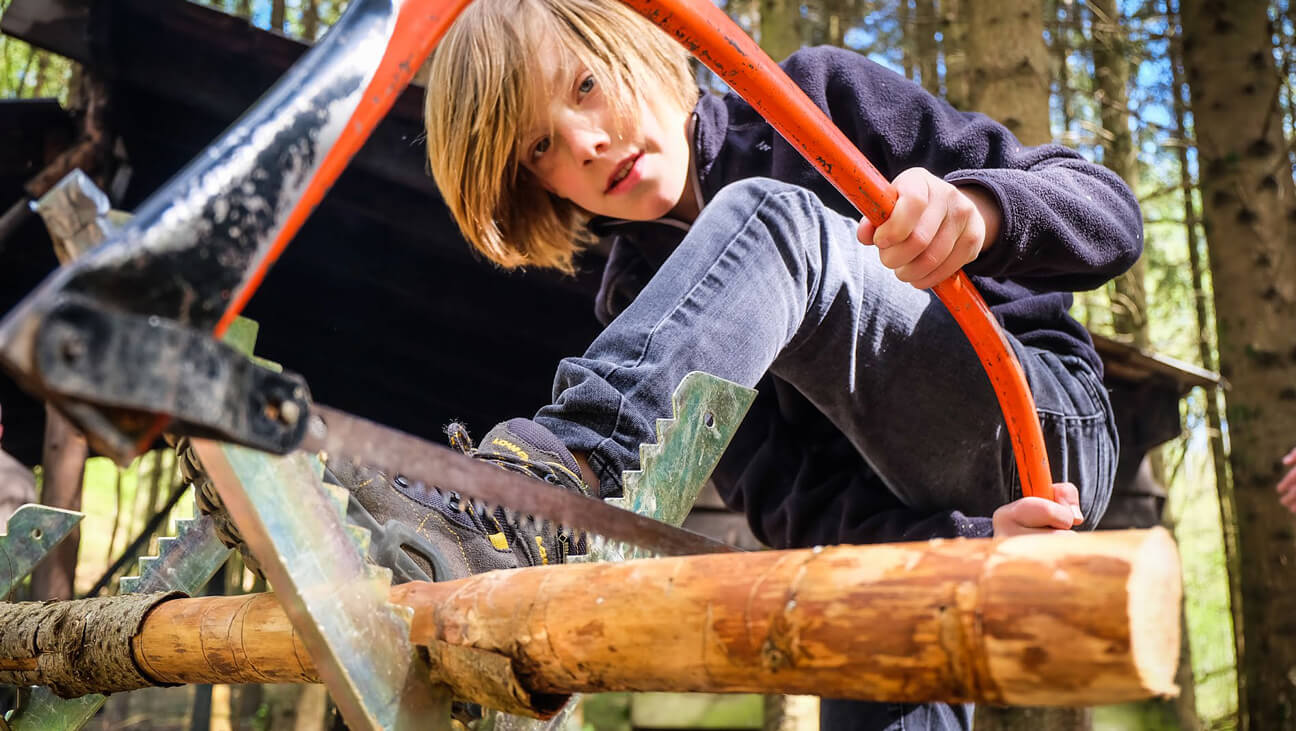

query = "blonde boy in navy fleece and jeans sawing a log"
[349, 0, 1142, 728]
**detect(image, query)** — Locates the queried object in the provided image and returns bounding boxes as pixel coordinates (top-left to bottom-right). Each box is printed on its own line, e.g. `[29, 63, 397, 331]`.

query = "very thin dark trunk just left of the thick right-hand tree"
[1165, 0, 1242, 720]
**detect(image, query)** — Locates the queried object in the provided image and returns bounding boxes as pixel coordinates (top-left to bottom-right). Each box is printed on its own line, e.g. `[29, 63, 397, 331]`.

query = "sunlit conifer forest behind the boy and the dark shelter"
[0, 0, 1296, 731]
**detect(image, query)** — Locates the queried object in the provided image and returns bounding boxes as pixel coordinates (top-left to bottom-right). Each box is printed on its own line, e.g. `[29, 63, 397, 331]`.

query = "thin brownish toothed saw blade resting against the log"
[301, 404, 737, 556]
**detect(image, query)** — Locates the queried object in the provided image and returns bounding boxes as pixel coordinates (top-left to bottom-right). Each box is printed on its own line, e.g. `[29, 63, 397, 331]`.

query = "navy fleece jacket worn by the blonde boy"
[591, 47, 1143, 548]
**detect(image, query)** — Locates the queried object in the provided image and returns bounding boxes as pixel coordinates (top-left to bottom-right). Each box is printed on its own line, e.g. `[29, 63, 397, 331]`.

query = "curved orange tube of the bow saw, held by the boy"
[623, 0, 1054, 500]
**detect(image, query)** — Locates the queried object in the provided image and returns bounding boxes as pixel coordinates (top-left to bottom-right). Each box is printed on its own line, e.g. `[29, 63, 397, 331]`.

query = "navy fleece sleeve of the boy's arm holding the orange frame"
[774, 47, 1143, 292]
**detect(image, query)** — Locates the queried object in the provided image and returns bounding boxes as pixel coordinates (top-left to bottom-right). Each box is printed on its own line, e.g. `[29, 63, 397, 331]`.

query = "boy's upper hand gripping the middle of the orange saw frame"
[857, 167, 1002, 289]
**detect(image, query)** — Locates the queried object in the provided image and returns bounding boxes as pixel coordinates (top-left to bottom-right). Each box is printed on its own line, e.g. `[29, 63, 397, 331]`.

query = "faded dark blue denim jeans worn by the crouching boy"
[535, 179, 1116, 728]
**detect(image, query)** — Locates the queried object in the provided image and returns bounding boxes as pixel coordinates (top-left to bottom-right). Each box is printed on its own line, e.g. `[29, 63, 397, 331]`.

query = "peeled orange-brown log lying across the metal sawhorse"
[0, 529, 1181, 717]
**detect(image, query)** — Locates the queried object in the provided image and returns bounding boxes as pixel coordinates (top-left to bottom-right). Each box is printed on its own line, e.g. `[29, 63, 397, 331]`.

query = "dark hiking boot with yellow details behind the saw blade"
[328, 419, 588, 582]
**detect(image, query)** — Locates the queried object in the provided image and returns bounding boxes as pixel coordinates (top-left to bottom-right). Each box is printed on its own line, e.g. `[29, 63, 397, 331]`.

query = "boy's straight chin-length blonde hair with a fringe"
[424, 0, 699, 273]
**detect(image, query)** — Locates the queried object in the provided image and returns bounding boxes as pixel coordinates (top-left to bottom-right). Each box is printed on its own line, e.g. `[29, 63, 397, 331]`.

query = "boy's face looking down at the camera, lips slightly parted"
[517, 44, 697, 220]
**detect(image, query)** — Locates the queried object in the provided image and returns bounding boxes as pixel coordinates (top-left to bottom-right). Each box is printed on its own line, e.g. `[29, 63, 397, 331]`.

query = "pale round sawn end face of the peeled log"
[1128, 528, 1183, 696]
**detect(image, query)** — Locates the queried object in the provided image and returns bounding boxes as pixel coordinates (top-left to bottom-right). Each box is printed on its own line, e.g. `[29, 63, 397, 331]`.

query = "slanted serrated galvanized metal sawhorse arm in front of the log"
[193, 439, 450, 730]
